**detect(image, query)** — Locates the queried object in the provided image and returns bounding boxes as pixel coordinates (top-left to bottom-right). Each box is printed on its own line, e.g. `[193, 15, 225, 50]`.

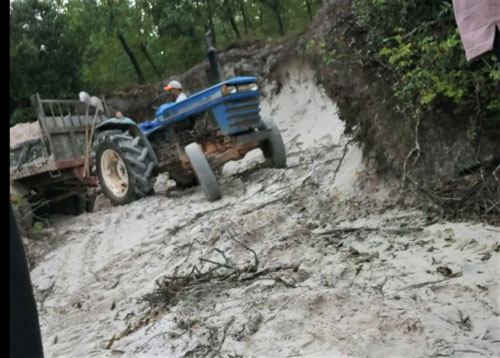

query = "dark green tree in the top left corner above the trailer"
[10, 0, 86, 125]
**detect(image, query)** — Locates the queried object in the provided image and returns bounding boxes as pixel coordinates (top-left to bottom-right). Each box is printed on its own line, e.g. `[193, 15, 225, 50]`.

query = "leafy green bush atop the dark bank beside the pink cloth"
[354, 0, 500, 121]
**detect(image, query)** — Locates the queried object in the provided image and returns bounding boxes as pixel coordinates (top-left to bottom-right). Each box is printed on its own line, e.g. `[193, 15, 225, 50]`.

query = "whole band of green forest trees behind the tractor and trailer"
[10, 0, 321, 125]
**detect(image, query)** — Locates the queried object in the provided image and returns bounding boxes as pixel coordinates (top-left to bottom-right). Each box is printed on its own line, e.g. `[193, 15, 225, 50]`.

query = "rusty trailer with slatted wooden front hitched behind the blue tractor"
[10, 94, 107, 223]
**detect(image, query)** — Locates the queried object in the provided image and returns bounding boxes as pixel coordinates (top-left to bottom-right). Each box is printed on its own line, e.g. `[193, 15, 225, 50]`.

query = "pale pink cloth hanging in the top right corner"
[453, 0, 500, 61]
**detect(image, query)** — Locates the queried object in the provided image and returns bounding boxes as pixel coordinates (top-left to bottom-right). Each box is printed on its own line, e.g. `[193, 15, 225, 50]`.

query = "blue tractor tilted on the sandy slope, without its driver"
[93, 77, 286, 205]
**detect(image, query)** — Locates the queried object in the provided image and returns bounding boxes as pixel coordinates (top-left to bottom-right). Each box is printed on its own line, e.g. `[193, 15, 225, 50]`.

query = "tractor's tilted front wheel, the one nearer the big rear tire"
[185, 143, 222, 201]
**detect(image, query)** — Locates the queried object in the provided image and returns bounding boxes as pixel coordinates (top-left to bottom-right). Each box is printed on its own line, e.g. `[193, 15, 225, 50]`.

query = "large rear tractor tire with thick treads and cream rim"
[95, 130, 156, 205]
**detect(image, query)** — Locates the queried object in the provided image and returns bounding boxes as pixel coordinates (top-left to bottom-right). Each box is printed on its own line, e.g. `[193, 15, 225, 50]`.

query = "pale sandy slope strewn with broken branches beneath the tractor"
[32, 61, 500, 357]
